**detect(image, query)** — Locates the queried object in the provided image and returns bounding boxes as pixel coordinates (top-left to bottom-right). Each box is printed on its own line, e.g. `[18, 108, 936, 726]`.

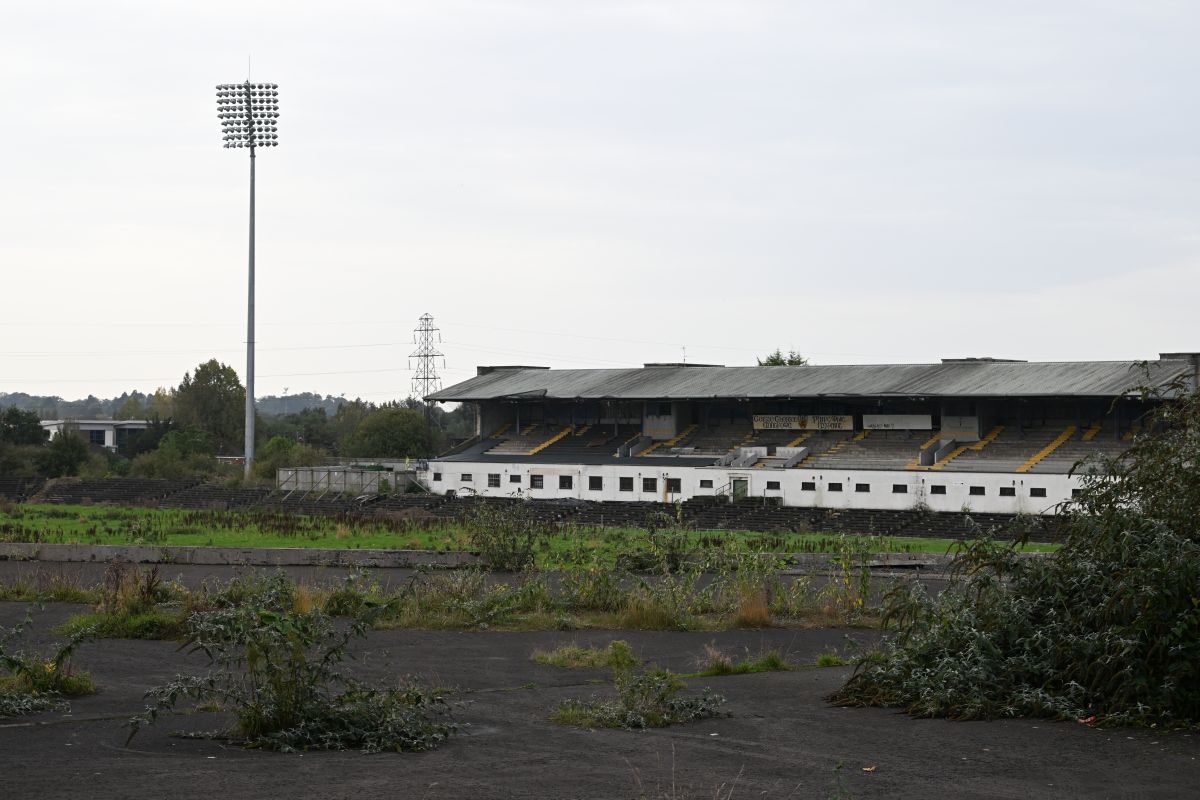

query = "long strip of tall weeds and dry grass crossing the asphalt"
[9, 506, 940, 638]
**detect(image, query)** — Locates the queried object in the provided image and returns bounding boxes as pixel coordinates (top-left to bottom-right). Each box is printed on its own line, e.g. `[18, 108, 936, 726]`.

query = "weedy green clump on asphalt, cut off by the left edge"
[0, 612, 96, 717]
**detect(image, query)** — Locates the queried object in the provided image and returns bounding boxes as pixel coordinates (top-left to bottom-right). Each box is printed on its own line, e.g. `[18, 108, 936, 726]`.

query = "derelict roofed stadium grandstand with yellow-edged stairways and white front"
[422, 353, 1200, 515]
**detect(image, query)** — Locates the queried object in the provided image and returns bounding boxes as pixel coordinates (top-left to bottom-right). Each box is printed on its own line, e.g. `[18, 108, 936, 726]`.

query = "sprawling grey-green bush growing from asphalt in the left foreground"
[130, 606, 456, 752]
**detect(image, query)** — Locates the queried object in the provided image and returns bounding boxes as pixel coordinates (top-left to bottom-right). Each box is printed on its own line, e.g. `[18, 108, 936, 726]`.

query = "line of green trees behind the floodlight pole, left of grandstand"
[0, 359, 474, 481]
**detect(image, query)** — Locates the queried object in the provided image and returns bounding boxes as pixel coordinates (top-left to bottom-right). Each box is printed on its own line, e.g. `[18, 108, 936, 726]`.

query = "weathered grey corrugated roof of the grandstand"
[428, 361, 1192, 402]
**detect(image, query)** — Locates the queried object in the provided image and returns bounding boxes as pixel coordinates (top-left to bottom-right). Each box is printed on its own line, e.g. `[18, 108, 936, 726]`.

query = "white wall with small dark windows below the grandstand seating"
[421, 458, 1079, 513]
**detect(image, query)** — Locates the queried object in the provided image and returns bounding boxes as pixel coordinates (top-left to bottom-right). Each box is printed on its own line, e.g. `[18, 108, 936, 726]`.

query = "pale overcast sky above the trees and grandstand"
[0, 0, 1200, 402]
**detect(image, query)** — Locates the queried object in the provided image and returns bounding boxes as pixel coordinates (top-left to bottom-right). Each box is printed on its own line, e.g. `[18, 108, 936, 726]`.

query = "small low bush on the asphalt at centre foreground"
[551, 669, 725, 728]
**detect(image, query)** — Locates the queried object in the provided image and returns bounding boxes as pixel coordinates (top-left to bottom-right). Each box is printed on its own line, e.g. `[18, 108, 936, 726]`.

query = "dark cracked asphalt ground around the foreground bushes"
[0, 603, 1200, 800]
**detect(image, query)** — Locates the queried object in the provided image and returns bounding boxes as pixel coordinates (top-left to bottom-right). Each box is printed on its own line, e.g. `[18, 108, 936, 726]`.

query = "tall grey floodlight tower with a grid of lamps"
[217, 79, 280, 477]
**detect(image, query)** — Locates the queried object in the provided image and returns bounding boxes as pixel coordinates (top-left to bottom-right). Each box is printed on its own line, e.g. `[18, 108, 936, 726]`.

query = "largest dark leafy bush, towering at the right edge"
[834, 387, 1200, 726]
